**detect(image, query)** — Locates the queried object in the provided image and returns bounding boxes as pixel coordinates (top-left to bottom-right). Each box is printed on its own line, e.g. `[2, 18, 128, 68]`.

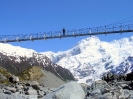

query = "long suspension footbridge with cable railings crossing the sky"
[0, 16, 133, 43]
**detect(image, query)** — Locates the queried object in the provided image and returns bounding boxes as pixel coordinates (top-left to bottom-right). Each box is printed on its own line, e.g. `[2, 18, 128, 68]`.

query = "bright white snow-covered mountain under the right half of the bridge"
[43, 36, 133, 84]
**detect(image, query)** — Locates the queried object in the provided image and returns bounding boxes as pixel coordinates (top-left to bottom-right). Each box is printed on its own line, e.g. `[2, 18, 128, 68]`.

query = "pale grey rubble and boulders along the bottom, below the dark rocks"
[0, 80, 133, 99]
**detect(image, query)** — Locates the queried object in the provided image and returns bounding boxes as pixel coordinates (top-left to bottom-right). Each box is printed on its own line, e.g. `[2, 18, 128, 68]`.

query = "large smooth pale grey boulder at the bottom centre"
[41, 82, 85, 99]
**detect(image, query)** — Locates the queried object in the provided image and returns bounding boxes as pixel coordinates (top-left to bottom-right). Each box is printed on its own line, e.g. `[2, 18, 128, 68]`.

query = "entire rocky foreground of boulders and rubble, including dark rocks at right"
[0, 72, 133, 99]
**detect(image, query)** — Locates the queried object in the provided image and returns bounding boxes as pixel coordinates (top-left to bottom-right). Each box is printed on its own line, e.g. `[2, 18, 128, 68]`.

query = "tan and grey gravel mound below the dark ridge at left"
[17, 66, 67, 88]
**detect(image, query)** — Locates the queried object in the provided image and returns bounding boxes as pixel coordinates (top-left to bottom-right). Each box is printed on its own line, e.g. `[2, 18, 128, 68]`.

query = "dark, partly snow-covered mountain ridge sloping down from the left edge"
[0, 43, 74, 80]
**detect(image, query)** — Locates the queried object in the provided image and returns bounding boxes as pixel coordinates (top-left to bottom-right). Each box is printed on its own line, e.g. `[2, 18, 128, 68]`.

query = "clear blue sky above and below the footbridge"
[0, 0, 133, 52]
